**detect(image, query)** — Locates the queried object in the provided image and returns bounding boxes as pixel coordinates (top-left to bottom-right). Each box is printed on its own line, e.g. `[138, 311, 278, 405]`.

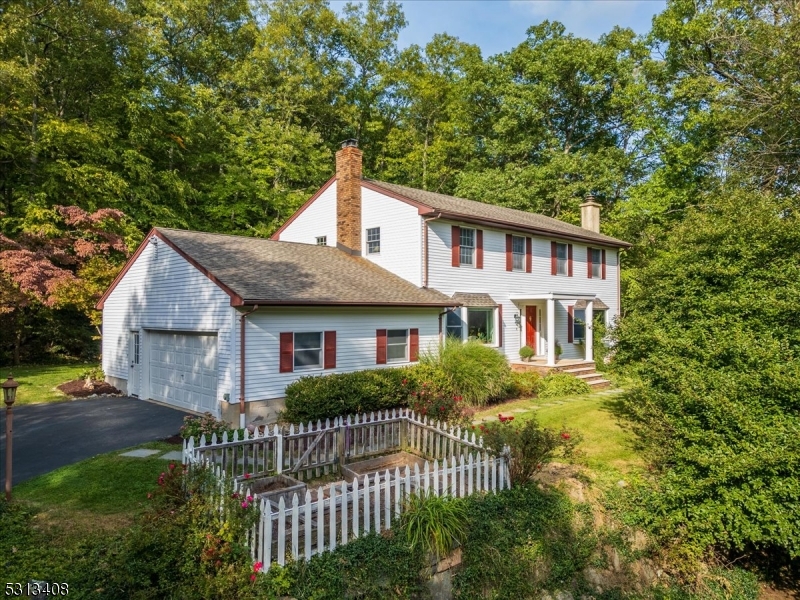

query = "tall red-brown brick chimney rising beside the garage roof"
[336, 140, 361, 256]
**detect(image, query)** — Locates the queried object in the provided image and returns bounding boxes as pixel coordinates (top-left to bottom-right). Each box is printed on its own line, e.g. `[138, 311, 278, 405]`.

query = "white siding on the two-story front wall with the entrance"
[428, 219, 619, 359]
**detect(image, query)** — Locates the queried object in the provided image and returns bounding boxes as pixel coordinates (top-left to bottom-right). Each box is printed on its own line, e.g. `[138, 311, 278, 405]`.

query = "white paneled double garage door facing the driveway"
[148, 331, 217, 414]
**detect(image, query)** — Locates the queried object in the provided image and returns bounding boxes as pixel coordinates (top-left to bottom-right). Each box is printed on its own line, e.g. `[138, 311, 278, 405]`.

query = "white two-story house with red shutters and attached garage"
[98, 142, 628, 424]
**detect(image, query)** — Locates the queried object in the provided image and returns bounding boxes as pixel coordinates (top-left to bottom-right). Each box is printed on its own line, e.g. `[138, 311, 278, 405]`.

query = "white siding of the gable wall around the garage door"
[102, 240, 232, 412]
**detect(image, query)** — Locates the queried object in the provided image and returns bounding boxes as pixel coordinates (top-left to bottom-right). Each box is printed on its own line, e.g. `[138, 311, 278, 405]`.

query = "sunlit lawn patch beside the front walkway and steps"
[476, 394, 644, 473]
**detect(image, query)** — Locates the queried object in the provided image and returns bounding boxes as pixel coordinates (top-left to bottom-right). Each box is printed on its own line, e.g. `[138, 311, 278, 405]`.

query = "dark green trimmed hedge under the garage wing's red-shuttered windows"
[283, 367, 413, 423]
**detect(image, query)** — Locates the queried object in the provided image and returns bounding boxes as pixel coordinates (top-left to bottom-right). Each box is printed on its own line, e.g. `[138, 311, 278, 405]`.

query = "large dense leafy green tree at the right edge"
[615, 189, 800, 557]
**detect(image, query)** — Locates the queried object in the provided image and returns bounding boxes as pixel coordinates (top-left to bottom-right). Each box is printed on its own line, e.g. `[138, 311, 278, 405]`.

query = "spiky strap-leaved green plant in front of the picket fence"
[400, 490, 467, 559]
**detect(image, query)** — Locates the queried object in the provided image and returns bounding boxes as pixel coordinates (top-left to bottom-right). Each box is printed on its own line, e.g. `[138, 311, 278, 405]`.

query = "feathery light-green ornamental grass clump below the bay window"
[420, 340, 511, 406]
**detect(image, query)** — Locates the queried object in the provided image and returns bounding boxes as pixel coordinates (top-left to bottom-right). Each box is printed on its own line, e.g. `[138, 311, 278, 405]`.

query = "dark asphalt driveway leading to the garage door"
[0, 397, 188, 484]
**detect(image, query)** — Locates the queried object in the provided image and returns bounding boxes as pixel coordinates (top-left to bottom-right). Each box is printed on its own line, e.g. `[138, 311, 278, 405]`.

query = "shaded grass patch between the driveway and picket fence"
[14, 442, 178, 518]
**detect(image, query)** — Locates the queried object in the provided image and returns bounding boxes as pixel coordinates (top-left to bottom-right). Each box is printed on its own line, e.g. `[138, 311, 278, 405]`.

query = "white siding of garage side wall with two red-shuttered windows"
[235, 307, 441, 400]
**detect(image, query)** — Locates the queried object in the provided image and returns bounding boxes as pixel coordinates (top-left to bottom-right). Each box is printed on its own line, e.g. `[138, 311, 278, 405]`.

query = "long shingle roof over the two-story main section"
[364, 179, 630, 247]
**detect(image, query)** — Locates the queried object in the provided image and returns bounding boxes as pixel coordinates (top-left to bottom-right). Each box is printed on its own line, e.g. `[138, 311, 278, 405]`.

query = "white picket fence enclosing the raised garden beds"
[183, 409, 511, 569]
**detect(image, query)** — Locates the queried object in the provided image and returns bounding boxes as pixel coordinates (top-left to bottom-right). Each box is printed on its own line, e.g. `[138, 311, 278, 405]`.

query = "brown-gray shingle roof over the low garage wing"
[156, 227, 457, 306]
